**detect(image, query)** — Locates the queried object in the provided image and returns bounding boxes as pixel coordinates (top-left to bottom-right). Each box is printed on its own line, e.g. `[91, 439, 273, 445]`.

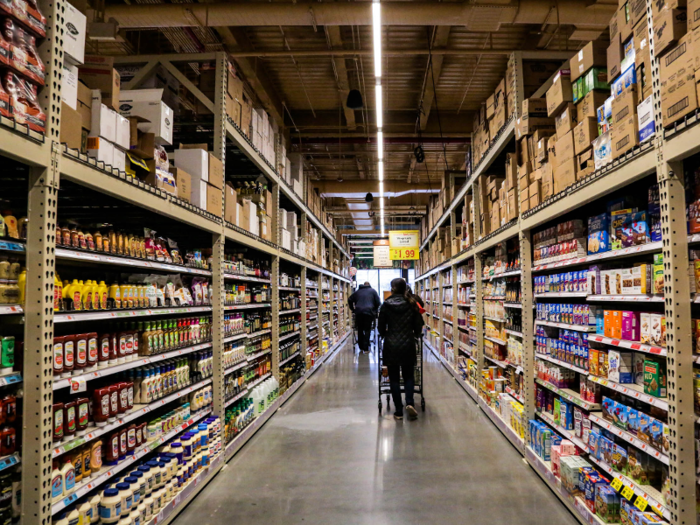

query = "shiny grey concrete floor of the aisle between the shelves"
[174, 343, 578, 525]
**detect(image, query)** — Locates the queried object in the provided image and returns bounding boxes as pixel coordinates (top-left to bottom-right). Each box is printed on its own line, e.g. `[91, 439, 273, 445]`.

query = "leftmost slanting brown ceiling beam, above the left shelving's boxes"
[215, 27, 284, 124]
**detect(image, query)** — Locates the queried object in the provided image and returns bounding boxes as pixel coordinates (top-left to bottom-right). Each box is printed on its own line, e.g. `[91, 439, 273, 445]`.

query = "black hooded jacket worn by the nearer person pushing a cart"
[377, 295, 423, 366]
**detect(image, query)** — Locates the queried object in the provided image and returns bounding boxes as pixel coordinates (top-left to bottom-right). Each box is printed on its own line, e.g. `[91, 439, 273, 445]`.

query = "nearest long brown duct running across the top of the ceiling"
[105, 0, 617, 32]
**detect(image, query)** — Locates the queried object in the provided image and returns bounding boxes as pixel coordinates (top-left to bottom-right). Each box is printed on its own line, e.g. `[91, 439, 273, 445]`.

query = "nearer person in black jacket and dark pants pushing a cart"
[378, 278, 423, 420]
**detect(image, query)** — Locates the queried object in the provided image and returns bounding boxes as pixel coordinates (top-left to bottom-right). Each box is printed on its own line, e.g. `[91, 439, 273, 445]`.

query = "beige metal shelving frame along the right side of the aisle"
[416, 16, 700, 525]
